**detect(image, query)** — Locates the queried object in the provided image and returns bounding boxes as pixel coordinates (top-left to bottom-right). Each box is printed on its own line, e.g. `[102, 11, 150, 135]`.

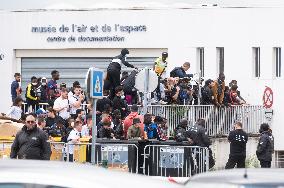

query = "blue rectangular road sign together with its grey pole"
[89, 68, 104, 164]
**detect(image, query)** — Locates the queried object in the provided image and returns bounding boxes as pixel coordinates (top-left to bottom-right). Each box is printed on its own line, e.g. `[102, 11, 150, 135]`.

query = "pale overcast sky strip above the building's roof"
[0, 0, 284, 10]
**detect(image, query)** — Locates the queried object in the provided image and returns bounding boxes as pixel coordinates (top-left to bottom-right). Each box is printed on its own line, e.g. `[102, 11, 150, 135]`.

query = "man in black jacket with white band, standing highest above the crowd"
[105, 48, 135, 99]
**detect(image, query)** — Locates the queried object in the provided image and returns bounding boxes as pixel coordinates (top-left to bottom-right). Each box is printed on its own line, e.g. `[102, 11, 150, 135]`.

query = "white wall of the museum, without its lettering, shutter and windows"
[0, 8, 284, 149]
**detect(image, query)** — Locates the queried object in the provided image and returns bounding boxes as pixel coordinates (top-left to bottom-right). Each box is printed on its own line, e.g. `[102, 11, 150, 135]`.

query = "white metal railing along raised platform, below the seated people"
[23, 103, 265, 137]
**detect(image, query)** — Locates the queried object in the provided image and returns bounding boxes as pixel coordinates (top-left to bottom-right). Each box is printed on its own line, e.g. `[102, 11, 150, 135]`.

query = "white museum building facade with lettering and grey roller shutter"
[0, 7, 284, 150]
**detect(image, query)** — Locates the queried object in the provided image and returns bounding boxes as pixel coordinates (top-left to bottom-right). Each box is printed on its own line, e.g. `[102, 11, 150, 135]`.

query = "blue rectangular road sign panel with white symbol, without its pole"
[90, 68, 104, 98]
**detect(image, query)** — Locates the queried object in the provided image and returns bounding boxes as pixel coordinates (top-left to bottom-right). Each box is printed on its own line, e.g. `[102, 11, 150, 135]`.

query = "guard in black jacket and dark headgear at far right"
[256, 123, 274, 168]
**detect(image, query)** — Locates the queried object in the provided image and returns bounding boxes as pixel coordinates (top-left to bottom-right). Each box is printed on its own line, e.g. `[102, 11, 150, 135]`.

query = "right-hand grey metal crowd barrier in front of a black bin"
[143, 145, 209, 177]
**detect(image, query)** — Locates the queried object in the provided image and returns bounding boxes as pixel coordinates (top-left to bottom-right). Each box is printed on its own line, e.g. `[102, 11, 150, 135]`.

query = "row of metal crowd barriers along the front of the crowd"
[0, 139, 209, 177]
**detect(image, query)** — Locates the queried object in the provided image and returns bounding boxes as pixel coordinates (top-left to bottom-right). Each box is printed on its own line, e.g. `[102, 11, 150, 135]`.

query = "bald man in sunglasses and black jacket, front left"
[10, 115, 51, 160]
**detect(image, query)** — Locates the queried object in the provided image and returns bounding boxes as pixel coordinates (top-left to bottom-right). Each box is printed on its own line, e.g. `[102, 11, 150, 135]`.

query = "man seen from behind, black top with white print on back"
[225, 122, 248, 169]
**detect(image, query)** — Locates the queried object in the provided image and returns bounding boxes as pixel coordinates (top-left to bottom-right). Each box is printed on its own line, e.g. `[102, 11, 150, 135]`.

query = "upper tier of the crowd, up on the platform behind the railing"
[10, 49, 246, 114]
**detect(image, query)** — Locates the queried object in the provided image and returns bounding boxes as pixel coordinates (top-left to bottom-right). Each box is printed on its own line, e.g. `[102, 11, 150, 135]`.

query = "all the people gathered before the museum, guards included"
[6, 49, 273, 168]
